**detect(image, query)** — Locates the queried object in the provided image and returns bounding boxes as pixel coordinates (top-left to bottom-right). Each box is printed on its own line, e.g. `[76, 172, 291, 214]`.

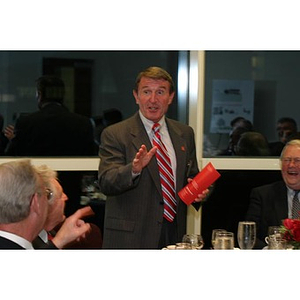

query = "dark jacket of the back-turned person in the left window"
[6, 103, 97, 156]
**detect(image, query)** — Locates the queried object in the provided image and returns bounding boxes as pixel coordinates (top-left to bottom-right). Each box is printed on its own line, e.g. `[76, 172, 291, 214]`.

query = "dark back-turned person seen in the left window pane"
[5, 76, 98, 156]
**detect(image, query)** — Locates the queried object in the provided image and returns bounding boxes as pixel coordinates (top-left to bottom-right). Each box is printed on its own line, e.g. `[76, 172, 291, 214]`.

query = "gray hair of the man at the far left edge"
[0, 160, 43, 224]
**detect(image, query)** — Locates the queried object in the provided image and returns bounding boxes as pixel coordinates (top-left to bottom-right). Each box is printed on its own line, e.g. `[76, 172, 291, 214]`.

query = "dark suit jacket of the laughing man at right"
[246, 181, 288, 248]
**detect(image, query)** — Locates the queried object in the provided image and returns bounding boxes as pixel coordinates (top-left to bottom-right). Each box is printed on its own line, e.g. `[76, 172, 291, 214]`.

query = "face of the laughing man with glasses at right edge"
[281, 145, 300, 190]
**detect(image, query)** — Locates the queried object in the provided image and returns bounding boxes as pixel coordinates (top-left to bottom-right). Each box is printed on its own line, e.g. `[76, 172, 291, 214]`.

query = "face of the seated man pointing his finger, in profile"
[45, 179, 68, 231]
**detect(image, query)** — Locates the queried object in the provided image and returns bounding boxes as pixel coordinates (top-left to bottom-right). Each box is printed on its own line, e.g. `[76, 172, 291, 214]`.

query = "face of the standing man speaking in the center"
[133, 77, 174, 123]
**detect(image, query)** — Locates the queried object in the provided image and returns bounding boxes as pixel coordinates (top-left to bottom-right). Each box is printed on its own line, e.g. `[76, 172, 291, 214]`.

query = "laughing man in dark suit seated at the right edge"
[246, 140, 300, 248]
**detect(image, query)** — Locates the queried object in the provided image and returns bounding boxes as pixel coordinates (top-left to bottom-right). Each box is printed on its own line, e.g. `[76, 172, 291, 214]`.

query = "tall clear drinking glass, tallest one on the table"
[237, 221, 256, 249]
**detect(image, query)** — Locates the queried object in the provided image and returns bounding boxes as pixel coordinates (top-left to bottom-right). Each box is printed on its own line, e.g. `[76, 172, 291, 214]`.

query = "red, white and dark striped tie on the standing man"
[152, 123, 177, 222]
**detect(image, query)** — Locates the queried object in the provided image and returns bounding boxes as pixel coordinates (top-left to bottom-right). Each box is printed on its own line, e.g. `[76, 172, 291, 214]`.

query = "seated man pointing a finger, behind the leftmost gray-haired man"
[32, 165, 102, 249]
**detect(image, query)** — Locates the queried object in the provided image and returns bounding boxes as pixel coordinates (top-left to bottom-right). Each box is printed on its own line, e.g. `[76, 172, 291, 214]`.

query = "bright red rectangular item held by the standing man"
[178, 163, 221, 205]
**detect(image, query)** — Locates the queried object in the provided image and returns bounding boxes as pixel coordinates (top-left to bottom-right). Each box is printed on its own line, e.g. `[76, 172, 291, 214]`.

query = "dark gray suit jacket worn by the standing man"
[99, 113, 198, 249]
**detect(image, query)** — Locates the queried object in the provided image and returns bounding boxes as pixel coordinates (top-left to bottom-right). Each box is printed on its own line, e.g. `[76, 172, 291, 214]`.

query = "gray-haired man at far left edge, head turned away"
[0, 160, 48, 249]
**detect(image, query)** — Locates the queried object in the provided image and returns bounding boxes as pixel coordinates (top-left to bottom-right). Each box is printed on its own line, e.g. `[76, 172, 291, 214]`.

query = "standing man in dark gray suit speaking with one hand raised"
[99, 67, 208, 249]
